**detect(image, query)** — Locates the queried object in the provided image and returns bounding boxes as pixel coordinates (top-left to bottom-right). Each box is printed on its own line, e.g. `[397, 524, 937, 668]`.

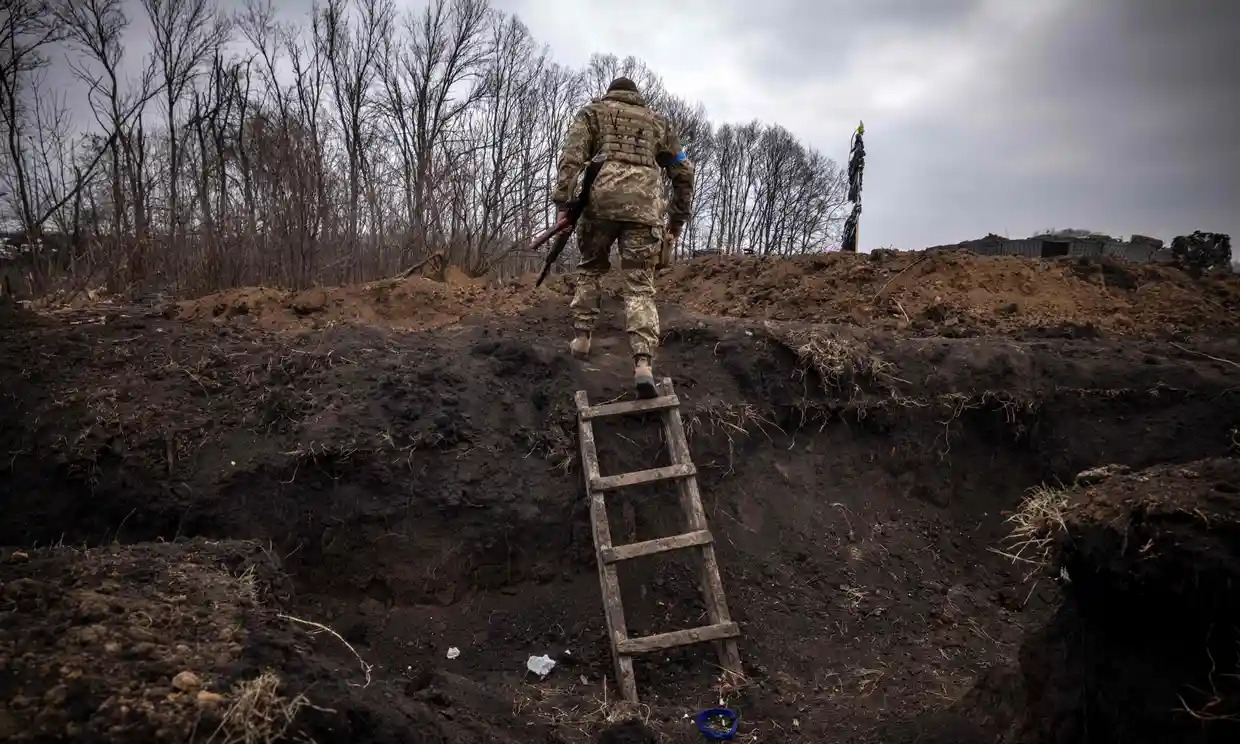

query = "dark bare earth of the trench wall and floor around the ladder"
[0, 292, 1240, 742]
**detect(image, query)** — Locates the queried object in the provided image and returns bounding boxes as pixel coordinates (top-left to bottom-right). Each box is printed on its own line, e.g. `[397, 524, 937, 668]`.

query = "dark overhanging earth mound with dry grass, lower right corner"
[1009, 459, 1240, 744]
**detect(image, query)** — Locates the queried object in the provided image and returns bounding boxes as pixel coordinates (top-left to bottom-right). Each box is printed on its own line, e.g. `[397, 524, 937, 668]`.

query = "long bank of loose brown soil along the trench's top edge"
[169, 250, 1240, 337]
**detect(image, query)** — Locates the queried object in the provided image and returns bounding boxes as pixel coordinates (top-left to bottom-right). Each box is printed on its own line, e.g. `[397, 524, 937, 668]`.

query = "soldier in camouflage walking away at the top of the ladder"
[552, 77, 693, 398]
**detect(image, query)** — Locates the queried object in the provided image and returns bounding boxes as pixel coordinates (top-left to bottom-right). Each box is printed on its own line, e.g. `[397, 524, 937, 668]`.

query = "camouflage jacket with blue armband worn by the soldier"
[552, 91, 693, 228]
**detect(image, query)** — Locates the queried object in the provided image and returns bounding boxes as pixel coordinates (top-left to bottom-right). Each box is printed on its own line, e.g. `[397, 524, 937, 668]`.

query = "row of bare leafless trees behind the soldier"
[0, 0, 847, 294]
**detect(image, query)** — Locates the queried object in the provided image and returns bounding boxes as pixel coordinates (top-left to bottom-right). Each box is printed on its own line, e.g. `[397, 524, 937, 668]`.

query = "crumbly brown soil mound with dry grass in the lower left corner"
[0, 539, 547, 744]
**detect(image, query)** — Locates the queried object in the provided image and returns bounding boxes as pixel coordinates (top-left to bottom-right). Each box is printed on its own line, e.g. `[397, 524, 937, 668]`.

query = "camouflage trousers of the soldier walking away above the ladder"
[569, 218, 663, 358]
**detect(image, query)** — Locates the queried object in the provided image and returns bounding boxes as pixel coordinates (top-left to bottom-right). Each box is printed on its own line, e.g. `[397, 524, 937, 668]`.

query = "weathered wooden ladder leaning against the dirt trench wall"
[577, 377, 742, 703]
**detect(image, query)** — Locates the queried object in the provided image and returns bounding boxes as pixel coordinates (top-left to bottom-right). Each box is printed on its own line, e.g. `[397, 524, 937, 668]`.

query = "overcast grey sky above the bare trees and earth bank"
[495, 0, 1240, 249]
